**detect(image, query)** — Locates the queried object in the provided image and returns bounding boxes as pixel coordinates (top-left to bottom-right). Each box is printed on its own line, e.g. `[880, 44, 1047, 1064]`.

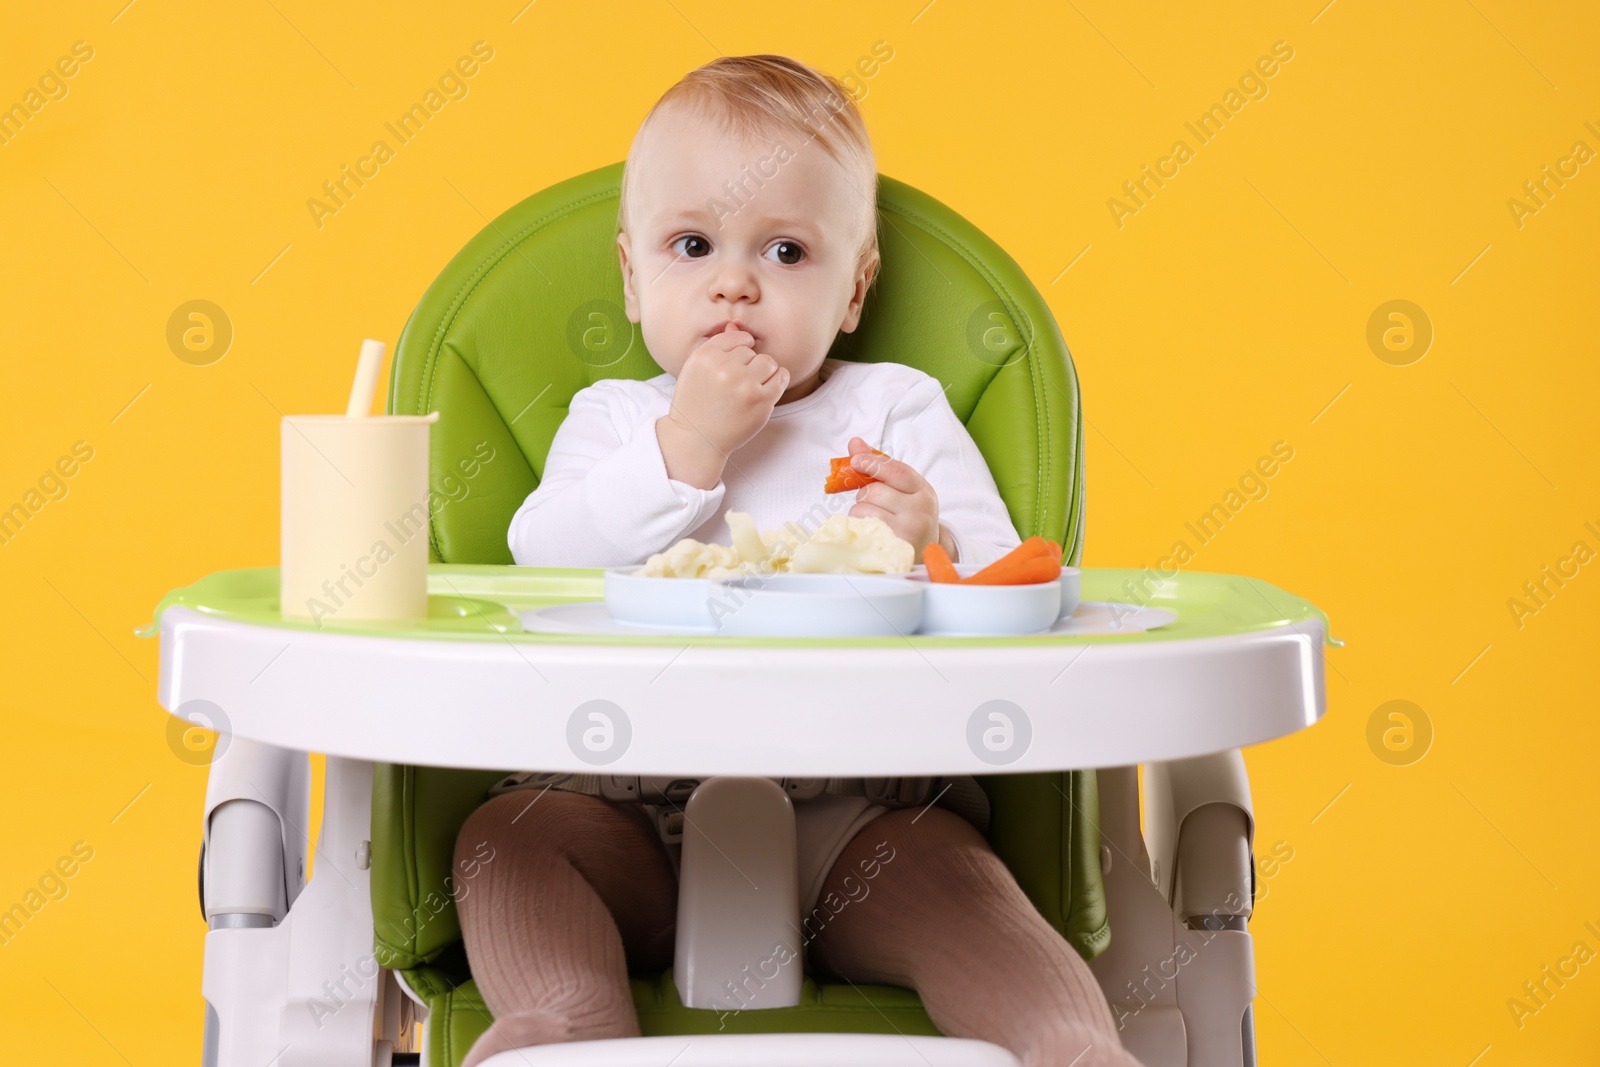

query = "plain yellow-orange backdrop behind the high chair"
[0, 0, 1600, 1067]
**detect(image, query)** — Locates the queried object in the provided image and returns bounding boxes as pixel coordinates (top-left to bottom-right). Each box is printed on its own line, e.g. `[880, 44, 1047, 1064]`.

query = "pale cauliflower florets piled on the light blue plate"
[638, 512, 917, 577]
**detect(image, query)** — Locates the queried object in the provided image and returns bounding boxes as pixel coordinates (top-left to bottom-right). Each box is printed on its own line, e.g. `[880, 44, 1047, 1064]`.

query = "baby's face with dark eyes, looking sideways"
[618, 107, 877, 403]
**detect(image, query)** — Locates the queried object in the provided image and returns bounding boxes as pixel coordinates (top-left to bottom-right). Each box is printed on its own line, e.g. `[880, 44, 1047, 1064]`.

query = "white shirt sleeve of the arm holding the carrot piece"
[885, 376, 1022, 566]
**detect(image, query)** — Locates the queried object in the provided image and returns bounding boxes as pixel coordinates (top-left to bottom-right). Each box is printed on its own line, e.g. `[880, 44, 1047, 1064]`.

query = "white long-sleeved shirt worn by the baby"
[507, 358, 1022, 566]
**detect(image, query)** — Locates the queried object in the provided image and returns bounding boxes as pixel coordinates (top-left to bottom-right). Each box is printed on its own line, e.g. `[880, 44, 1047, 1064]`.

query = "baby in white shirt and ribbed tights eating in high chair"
[456, 56, 1138, 1067]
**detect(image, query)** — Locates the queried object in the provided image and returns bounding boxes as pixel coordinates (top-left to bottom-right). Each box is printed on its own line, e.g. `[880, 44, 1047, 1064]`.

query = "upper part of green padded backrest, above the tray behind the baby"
[389, 163, 1083, 565]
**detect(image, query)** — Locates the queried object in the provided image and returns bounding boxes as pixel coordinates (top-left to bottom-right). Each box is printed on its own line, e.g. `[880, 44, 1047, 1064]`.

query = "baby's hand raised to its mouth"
[670, 323, 789, 458]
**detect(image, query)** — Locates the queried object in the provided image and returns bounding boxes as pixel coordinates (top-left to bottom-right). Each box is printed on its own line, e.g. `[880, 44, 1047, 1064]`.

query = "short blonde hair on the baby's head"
[616, 56, 878, 283]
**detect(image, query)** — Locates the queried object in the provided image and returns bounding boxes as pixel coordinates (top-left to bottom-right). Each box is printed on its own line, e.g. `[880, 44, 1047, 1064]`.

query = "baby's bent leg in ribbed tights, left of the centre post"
[454, 790, 678, 1067]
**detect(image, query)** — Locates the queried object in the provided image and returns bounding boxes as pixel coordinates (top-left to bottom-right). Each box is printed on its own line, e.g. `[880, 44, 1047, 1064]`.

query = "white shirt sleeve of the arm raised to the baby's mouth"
[507, 381, 728, 566]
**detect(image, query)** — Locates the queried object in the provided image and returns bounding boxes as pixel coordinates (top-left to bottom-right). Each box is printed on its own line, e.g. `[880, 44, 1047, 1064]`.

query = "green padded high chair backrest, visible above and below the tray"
[371, 163, 1109, 977]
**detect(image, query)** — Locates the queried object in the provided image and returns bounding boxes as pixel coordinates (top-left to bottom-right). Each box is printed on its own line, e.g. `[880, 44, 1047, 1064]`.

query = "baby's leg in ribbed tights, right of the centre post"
[810, 808, 1139, 1067]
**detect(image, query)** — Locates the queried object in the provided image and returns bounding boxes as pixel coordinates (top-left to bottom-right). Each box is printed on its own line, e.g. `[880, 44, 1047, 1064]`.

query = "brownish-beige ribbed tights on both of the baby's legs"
[456, 790, 1139, 1067]
